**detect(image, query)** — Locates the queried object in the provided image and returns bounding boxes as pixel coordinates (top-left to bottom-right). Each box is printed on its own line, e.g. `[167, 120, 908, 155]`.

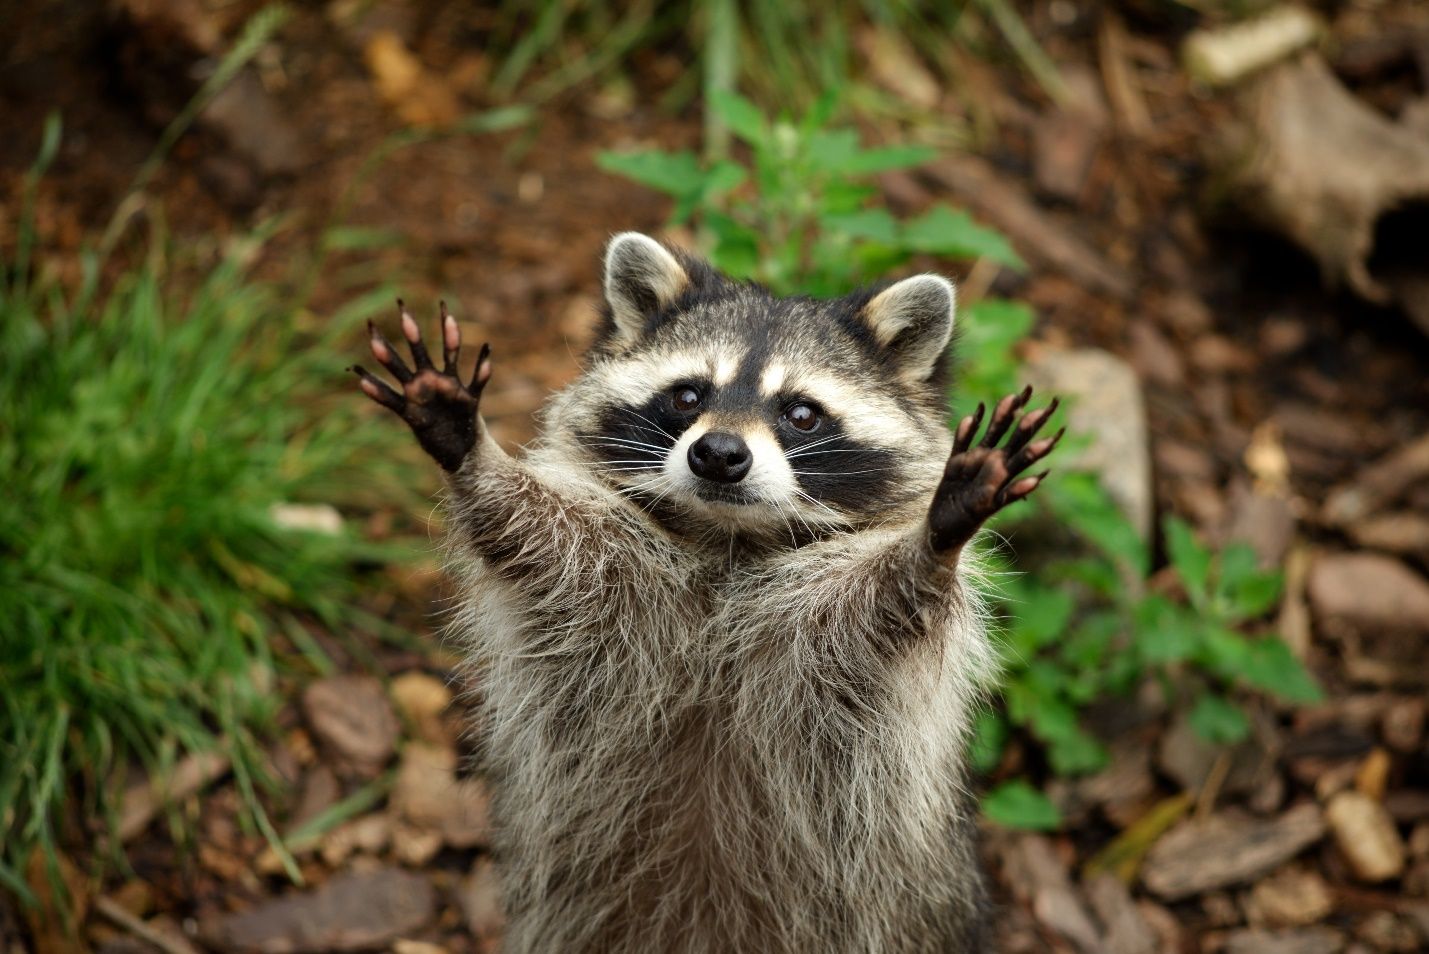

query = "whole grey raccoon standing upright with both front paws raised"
[353, 233, 1060, 954]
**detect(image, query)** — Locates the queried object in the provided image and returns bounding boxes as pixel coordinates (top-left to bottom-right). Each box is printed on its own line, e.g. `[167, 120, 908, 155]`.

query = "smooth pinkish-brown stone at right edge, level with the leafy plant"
[1309, 553, 1429, 634]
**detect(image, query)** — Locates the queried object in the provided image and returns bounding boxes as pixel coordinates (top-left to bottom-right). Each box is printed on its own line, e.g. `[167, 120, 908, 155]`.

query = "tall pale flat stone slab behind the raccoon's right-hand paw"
[1026, 348, 1152, 540]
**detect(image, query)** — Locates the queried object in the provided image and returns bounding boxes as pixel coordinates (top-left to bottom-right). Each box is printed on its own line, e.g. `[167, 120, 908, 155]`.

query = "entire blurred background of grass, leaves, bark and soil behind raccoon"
[0, 0, 1429, 954]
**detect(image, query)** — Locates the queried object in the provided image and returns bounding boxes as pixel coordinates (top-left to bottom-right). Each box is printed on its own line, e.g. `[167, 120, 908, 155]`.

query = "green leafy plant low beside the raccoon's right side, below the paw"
[973, 491, 1320, 824]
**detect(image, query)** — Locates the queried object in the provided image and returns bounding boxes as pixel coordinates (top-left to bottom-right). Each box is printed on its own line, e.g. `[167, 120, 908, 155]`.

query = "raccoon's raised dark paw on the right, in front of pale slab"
[927, 387, 1066, 553]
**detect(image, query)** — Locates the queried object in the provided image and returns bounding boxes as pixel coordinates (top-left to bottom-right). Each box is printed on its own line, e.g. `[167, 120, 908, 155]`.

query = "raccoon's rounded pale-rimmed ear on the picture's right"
[860, 274, 957, 384]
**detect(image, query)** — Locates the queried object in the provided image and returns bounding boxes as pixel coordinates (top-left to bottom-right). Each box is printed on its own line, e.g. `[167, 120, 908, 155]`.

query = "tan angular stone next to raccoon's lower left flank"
[392, 743, 492, 848]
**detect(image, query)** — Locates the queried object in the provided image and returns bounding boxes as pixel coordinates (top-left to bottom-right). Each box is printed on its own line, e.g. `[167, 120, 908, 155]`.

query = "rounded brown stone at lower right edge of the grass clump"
[303, 676, 399, 775]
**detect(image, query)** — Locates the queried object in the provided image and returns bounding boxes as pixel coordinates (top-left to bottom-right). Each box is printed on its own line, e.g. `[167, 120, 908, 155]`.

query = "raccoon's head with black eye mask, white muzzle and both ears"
[552, 233, 955, 543]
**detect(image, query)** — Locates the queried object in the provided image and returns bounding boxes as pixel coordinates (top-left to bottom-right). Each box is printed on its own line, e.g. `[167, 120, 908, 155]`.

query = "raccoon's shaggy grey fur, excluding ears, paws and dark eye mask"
[447, 234, 993, 954]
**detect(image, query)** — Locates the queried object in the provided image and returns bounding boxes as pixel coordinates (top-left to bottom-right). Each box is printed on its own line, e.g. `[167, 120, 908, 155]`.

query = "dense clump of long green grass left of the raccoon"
[0, 120, 409, 895]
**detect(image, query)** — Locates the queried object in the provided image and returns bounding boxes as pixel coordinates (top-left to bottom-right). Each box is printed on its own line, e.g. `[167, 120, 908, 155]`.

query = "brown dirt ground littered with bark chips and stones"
[0, 0, 1429, 954]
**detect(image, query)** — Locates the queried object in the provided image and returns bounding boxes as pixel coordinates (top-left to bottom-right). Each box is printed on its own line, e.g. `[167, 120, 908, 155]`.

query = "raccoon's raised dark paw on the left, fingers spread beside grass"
[349, 298, 492, 471]
